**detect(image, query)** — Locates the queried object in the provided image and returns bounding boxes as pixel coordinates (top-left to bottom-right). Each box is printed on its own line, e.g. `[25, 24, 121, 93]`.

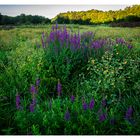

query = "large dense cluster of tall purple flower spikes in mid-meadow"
[37, 24, 132, 60]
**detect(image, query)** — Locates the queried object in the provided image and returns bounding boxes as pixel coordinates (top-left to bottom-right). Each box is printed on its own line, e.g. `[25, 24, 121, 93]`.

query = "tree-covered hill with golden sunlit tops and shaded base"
[52, 5, 140, 24]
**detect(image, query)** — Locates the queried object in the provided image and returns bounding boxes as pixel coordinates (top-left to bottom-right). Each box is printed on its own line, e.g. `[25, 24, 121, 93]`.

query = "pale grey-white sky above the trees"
[0, 5, 129, 19]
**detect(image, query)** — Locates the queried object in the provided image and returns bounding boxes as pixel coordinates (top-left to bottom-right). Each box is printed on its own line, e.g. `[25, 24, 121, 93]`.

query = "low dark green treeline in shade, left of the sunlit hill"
[0, 13, 51, 25]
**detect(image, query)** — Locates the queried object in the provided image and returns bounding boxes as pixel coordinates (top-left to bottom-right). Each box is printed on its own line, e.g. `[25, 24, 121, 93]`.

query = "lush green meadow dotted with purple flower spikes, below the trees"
[0, 24, 140, 135]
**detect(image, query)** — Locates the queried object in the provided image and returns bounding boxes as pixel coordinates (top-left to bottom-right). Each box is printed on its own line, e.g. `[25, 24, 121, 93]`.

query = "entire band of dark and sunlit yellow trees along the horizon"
[0, 5, 140, 27]
